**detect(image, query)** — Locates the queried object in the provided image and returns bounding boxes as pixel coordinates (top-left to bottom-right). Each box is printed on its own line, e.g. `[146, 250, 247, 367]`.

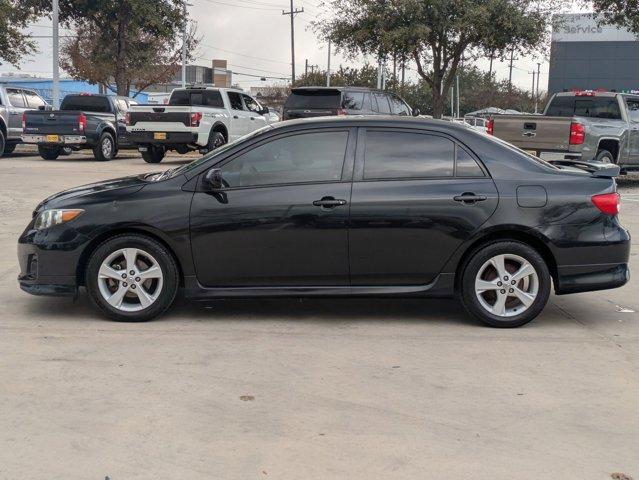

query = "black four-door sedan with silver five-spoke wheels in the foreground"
[18, 117, 630, 327]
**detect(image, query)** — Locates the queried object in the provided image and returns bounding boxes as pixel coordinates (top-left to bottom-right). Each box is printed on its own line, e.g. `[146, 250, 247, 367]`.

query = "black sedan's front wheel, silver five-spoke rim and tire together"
[85, 235, 178, 322]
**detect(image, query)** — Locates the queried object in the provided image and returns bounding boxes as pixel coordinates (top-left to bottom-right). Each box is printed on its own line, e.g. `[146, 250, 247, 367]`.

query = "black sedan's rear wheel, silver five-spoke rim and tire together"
[461, 241, 551, 327]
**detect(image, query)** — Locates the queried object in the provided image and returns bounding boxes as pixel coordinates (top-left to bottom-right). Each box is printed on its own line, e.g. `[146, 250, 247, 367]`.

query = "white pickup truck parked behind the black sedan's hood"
[126, 87, 271, 163]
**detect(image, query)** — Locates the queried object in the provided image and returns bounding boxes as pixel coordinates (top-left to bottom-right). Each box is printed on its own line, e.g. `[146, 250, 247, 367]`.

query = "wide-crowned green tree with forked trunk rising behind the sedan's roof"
[315, 0, 554, 118]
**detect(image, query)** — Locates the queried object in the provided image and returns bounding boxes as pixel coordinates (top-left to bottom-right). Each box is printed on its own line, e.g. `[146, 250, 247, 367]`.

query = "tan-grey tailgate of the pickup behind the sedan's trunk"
[493, 115, 573, 151]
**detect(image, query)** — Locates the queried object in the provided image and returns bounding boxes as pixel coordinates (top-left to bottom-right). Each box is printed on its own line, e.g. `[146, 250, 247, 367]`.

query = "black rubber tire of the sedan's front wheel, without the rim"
[85, 234, 179, 322]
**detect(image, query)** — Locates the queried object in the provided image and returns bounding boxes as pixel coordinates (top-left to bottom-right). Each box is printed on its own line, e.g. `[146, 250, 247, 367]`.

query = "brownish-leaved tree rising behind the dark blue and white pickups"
[25, 0, 198, 95]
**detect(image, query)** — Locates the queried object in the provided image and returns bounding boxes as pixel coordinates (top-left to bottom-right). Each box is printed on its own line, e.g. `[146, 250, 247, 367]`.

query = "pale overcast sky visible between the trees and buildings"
[0, 0, 583, 94]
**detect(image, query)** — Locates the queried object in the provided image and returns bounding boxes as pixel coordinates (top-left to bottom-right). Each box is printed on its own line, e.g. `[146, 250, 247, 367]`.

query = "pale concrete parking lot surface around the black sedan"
[0, 149, 639, 480]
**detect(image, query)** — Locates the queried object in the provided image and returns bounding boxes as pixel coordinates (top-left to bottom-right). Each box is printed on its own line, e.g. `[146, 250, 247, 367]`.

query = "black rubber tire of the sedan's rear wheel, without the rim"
[460, 240, 551, 328]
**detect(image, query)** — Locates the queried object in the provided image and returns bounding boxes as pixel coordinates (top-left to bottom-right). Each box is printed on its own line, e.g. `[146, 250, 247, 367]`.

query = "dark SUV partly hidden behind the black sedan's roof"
[282, 87, 419, 120]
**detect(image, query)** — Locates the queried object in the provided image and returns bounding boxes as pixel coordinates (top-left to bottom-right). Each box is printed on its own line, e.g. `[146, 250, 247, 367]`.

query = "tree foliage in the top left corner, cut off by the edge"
[0, 0, 36, 67]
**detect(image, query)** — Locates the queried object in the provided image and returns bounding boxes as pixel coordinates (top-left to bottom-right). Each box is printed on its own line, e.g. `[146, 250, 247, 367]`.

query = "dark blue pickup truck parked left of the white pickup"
[22, 93, 136, 161]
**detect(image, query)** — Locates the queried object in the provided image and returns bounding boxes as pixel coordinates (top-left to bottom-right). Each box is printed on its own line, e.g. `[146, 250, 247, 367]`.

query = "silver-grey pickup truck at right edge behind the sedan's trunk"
[488, 91, 639, 172]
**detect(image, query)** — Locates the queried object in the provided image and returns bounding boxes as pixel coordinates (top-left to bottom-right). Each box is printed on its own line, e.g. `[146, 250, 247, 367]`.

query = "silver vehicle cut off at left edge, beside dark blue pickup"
[0, 85, 48, 157]
